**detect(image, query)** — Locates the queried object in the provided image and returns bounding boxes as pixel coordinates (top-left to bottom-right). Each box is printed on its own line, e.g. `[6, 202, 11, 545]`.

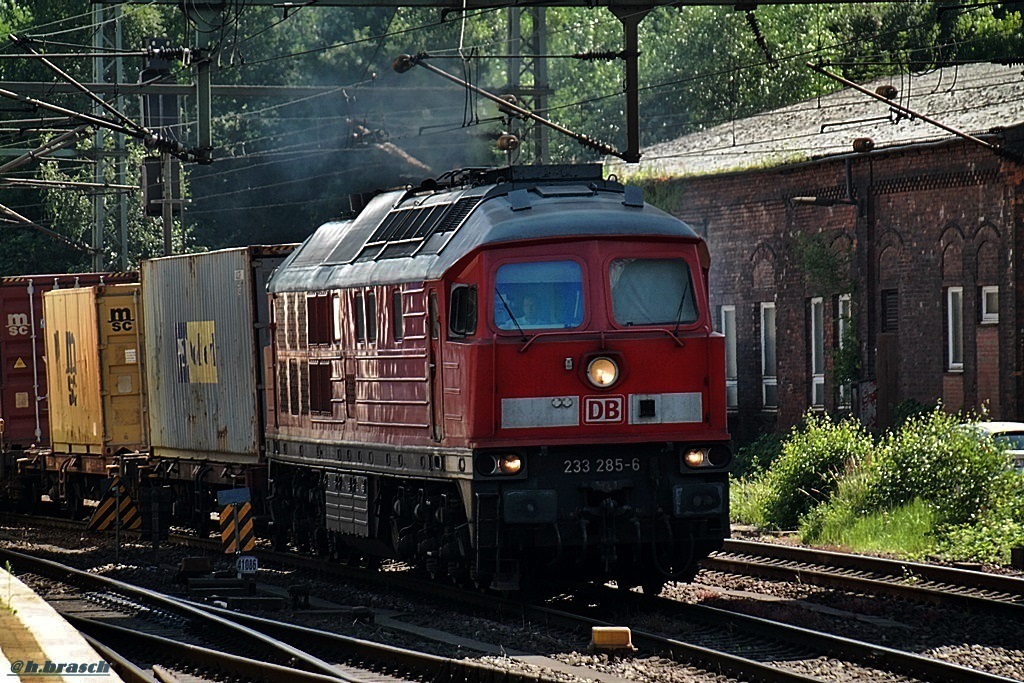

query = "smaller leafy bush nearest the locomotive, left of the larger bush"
[762, 415, 872, 528]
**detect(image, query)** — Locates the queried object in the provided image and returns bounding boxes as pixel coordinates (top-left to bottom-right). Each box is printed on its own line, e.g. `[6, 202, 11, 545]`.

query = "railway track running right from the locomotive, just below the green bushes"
[701, 539, 1024, 618]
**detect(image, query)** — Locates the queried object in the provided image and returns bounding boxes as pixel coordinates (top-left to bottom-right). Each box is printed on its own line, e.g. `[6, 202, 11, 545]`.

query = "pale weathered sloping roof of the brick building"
[630, 63, 1024, 176]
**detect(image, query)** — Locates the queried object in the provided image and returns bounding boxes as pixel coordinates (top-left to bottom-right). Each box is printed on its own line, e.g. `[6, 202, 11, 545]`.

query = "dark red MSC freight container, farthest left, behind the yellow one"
[0, 272, 138, 451]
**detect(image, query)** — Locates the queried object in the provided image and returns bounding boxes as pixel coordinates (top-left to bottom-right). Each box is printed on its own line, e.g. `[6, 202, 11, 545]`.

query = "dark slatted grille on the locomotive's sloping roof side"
[352, 197, 482, 263]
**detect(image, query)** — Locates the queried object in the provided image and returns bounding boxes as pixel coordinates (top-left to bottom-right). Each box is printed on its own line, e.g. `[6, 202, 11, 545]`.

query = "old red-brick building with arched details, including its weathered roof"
[622, 65, 1024, 442]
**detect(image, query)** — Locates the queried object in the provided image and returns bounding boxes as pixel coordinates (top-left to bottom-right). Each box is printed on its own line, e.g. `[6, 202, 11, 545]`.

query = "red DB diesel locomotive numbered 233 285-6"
[266, 167, 731, 592]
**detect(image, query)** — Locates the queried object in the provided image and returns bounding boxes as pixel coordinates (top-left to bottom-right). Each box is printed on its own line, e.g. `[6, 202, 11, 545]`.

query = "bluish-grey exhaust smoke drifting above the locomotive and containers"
[185, 56, 498, 248]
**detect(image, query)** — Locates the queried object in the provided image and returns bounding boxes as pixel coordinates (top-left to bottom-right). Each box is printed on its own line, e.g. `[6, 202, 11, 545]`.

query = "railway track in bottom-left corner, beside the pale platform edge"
[0, 549, 556, 683]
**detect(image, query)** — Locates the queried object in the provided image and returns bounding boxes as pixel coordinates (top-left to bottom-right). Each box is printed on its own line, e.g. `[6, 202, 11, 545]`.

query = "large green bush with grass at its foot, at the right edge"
[801, 409, 1024, 561]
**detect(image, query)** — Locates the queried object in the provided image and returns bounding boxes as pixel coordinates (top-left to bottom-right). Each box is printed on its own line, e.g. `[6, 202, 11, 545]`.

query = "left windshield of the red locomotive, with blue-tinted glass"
[495, 261, 584, 331]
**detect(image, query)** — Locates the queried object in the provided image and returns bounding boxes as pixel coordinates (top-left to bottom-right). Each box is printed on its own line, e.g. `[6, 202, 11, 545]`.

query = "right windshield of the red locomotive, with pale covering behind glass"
[609, 258, 697, 327]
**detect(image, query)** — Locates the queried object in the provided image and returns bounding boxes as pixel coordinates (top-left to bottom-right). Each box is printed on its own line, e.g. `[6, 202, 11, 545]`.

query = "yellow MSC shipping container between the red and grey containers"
[43, 285, 148, 455]
